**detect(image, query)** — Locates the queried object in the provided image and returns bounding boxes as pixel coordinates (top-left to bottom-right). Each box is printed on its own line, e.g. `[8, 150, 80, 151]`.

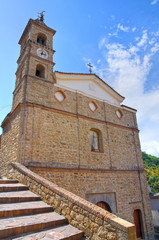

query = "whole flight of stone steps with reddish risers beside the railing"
[0, 179, 85, 240]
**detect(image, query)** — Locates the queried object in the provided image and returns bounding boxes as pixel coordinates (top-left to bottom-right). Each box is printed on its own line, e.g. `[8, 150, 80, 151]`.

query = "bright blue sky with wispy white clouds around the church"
[0, 0, 159, 156]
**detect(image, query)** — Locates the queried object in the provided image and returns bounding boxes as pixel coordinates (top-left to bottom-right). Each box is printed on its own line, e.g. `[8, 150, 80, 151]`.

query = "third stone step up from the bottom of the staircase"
[0, 201, 53, 218]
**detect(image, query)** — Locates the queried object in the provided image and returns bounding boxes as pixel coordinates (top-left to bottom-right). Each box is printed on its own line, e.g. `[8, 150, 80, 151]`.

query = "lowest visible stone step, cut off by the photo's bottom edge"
[4, 224, 85, 240]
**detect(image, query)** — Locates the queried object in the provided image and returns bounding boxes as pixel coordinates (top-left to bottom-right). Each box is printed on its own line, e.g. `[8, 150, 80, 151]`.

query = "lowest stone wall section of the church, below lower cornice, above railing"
[29, 167, 153, 239]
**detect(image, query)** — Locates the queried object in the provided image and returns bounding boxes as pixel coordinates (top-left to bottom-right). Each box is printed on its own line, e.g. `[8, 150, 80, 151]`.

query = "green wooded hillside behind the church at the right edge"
[142, 152, 159, 193]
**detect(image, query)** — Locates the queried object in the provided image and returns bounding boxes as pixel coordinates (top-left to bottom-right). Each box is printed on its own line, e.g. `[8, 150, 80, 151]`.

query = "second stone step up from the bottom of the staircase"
[0, 212, 66, 239]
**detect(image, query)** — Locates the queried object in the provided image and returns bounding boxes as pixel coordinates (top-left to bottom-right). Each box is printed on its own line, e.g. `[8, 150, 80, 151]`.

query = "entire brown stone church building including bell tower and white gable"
[0, 19, 153, 239]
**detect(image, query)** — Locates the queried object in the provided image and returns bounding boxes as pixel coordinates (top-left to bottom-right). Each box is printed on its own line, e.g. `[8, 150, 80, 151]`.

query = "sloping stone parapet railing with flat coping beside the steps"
[8, 163, 136, 240]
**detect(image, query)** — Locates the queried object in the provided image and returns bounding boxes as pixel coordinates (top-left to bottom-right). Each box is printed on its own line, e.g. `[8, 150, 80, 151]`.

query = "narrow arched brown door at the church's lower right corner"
[133, 209, 144, 238]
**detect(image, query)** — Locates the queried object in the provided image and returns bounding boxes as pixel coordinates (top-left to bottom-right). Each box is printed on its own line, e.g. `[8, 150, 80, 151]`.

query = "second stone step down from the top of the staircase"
[0, 183, 29, 192]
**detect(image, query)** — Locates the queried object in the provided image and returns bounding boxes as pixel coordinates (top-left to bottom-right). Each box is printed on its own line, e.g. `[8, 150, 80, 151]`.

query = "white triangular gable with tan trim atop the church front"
[55, 71, 124, 105]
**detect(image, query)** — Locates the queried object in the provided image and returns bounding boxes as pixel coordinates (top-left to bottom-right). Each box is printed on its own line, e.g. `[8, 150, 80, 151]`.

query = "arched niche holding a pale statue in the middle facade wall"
[90, 129, 102, 152]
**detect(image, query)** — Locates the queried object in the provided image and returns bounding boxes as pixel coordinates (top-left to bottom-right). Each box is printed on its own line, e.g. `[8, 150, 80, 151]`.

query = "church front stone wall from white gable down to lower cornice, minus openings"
[14, 77, 143, 169]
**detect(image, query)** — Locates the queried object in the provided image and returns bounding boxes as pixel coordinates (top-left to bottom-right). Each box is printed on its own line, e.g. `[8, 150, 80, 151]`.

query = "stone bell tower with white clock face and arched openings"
[12, 15, 56, 110]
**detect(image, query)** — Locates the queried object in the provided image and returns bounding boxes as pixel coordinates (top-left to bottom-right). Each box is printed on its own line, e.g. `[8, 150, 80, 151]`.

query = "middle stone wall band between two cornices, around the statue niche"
[23, 104, 143, 169]
